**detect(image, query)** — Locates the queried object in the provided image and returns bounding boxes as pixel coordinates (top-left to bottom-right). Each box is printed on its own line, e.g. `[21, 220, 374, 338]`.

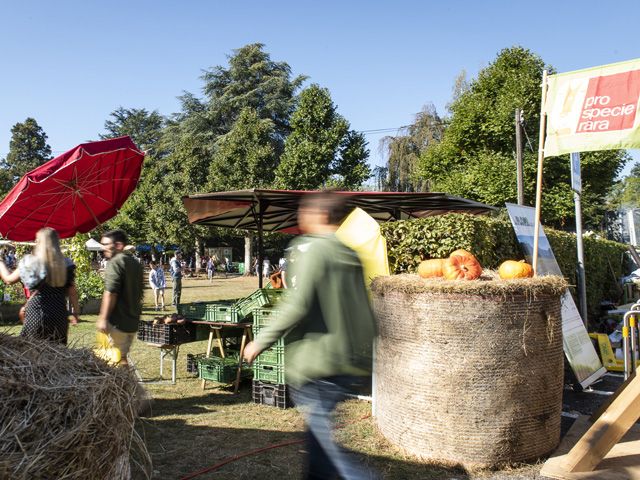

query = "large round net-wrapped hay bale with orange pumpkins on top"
[372, 275, 567, 467]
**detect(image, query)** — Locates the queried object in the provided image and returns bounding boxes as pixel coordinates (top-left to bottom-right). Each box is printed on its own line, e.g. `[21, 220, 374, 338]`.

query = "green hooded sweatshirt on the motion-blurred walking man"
[255, 234, 376, 387]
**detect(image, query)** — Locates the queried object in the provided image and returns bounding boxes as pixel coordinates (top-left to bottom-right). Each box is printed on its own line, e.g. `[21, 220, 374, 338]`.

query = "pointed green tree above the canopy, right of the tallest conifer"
[276, 84, 371, 190]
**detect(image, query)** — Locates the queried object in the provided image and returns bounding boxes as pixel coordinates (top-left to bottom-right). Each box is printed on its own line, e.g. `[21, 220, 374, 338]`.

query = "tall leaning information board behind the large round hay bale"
[507, 203, 607, 388]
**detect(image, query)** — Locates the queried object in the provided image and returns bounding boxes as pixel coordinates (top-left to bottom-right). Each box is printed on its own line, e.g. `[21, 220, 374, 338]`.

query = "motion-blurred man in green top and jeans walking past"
[244, 192, 378, 480]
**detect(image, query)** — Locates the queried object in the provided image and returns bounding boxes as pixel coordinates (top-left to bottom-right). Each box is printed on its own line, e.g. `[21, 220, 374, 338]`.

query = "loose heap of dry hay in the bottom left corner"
[0, 333, 150, 480]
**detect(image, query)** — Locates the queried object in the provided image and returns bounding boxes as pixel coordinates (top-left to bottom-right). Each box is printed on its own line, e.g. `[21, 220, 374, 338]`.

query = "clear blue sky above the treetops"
[0, 0, 640, 172]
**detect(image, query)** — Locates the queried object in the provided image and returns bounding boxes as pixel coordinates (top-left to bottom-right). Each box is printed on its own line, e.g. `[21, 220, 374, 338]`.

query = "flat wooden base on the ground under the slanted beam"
[540, 416, 640, 480]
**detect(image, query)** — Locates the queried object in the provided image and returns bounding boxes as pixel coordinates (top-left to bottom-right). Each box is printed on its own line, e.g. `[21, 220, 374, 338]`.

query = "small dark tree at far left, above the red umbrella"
[1, 118, 51, 194]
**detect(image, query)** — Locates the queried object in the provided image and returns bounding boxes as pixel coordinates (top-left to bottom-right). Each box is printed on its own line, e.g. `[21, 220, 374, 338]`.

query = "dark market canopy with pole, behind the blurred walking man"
[182, 189, 495, 287]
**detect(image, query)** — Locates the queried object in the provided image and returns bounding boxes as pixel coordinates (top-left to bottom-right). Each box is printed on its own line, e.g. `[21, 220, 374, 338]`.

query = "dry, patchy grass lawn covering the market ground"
[2, 277, 539, 480]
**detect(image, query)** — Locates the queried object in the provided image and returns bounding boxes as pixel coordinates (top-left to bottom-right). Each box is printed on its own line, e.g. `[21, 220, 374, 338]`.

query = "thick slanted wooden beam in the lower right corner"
[563, 377, 640, 472]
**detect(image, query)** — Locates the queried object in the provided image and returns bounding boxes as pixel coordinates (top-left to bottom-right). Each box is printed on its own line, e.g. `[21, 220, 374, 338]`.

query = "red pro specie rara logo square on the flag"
[576, 70, 640, 133]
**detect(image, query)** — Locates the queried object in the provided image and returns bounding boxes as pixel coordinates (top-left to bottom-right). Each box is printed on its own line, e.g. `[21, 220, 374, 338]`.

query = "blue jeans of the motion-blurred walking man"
[291, 376, 379, 480]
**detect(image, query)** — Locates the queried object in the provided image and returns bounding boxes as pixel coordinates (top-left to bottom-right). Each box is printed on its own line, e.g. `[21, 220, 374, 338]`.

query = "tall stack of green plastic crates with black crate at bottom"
[252, 308, 291, 408]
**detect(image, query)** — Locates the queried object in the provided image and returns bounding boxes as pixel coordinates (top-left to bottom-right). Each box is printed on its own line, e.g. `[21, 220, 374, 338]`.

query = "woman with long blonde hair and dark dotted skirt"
[0, 228, 80, 345]
